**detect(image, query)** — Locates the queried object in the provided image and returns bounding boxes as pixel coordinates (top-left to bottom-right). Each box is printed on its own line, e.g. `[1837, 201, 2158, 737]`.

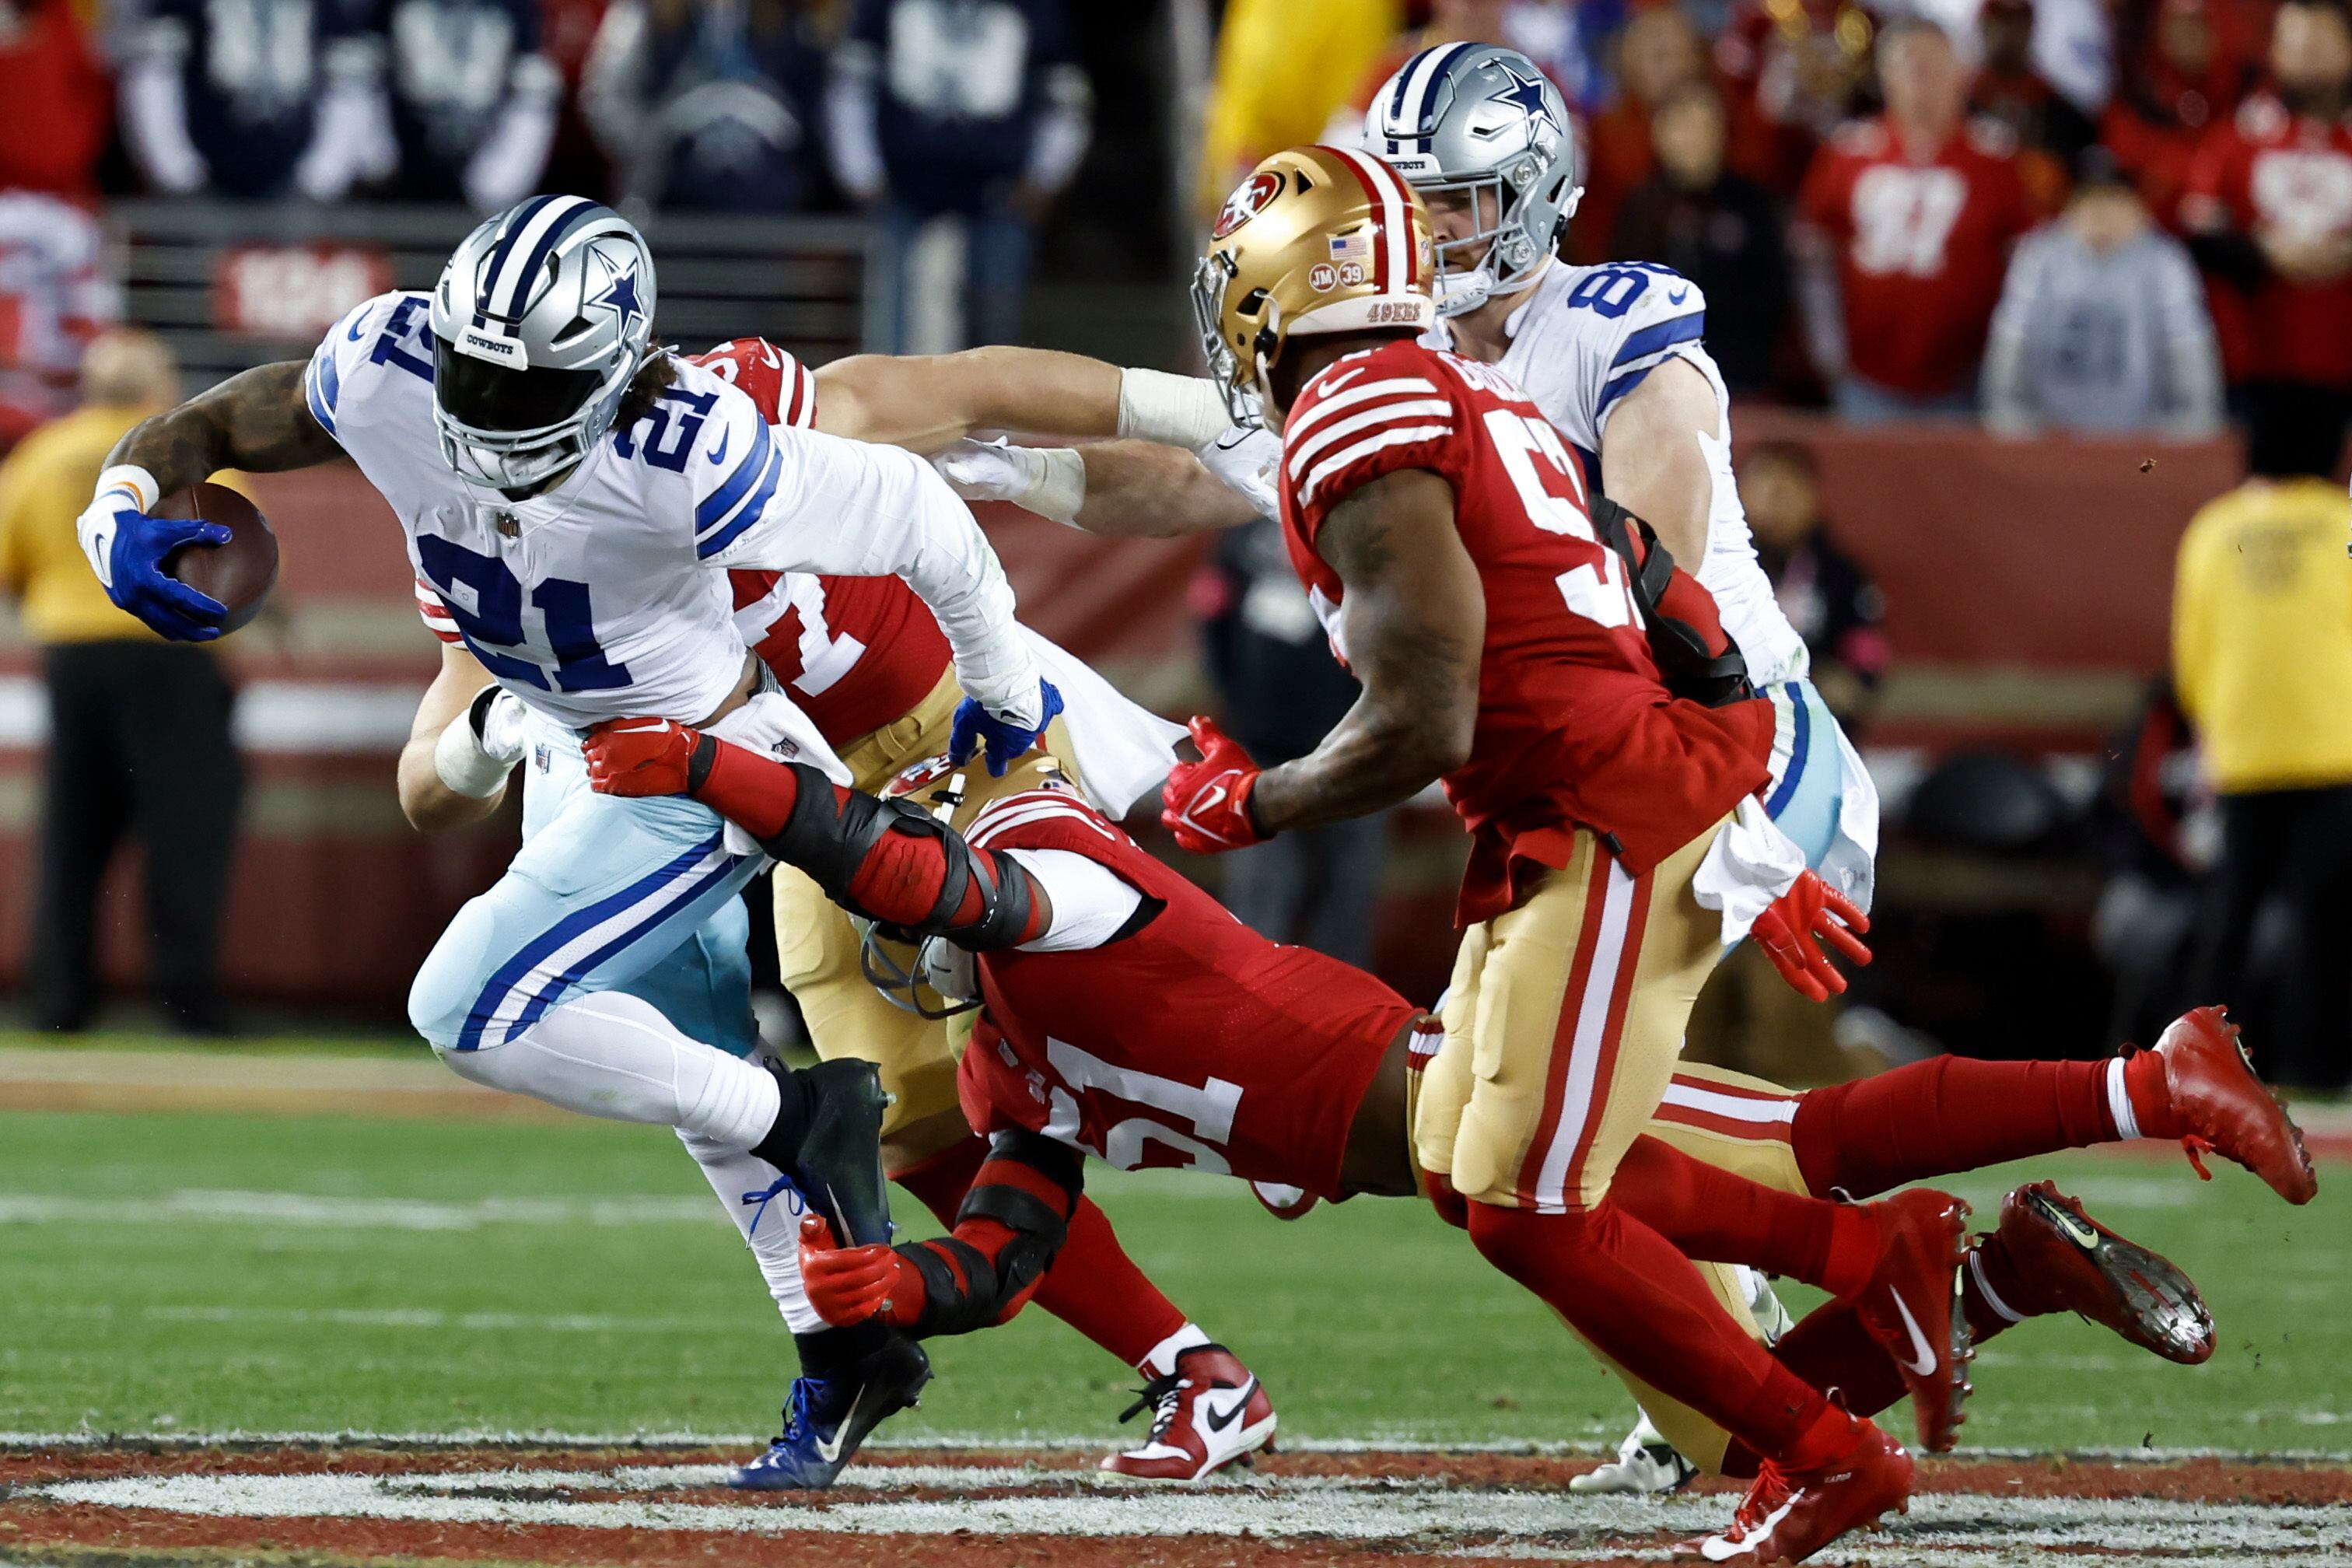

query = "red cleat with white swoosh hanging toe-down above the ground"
[1853, 1187, 1976, 1453]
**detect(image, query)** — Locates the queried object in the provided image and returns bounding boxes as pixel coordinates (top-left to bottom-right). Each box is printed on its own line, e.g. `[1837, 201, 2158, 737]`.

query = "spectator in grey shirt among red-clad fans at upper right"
[1985, 148, 2221, 439]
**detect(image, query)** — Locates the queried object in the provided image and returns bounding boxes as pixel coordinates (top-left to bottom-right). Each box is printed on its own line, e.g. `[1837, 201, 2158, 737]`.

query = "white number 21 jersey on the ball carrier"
[306, 294, 1038, 726]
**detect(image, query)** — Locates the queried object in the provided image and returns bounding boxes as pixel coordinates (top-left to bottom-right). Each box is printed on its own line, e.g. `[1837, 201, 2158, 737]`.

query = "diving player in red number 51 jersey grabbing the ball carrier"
[573, 722, 2310, 1519]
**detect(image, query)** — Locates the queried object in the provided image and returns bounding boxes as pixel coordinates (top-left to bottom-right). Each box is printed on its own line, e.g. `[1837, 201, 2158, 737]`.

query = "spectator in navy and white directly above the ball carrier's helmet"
[379, 0, 562, 212]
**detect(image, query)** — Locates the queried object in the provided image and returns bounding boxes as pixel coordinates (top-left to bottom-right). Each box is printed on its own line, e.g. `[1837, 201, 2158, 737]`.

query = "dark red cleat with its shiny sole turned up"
[1969, 1182, 2214, 1366]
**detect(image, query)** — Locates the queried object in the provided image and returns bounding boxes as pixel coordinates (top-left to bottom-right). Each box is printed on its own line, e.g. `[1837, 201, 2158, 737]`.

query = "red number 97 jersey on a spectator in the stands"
[1797, 120, 2039, 395]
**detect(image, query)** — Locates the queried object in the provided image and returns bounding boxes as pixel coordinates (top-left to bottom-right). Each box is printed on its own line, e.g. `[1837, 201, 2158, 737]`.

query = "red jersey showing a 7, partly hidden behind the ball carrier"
[694, 338, 953, 745]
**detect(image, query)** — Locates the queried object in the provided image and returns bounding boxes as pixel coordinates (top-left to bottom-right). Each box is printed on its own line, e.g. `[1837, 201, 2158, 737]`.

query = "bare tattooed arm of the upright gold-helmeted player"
[1249, 467, 1486, 832]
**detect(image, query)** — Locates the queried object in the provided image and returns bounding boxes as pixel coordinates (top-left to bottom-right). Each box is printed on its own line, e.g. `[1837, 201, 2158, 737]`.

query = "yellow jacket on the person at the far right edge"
[2173, 480, 2352, 795]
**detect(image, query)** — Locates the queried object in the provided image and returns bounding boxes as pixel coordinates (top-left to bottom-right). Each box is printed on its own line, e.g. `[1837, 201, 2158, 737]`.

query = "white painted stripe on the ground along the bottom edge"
[19, 1467, 2352, 1566]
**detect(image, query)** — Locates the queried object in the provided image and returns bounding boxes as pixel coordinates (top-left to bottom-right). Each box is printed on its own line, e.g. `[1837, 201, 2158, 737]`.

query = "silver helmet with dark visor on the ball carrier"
[432, 195, 654, 492]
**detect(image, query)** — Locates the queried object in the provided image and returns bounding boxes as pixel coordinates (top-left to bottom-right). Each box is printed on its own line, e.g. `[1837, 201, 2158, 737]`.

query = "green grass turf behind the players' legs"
[0, 1112, 2352, 1451]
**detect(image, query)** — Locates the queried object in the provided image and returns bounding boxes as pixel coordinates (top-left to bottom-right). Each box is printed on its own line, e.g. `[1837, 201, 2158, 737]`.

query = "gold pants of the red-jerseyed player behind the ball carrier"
[774, 670, 1077, 1159]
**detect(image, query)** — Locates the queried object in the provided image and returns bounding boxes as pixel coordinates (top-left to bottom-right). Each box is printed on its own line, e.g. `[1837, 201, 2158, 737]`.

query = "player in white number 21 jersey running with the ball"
[80, 195, 1061, 1462]
